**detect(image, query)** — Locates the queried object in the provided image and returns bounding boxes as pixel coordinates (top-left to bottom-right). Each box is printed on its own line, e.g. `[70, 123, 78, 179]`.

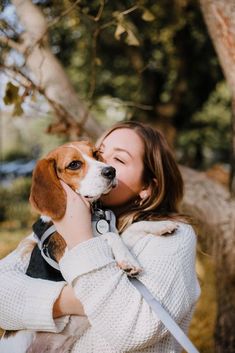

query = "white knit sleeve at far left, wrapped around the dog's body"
[0, 236, 68, 332]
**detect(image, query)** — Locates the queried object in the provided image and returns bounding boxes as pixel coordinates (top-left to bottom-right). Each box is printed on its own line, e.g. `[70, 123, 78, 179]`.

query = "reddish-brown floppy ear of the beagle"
[29, 159, 66, 220]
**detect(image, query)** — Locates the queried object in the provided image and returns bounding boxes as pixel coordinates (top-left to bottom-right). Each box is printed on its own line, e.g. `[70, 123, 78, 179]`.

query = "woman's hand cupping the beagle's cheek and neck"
[53, 181, 93, 249]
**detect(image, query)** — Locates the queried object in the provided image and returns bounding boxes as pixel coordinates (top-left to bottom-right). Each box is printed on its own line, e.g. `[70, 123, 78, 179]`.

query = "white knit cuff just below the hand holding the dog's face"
[59, 235, 115, 284]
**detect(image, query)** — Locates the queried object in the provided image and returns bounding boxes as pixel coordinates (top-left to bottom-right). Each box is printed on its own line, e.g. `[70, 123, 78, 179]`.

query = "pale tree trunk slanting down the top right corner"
[200, 0, 235, 197]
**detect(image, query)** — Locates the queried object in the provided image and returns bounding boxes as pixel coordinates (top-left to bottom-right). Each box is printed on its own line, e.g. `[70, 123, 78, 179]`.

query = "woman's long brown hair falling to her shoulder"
[98, 121, 187, 232]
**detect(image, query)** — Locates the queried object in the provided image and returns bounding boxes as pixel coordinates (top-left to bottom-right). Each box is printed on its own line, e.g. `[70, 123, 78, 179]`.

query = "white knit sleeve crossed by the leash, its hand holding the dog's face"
[60, 223, 200, 352]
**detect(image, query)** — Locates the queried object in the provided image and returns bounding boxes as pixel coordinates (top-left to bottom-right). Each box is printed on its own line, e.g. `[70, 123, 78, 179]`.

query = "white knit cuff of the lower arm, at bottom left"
[23, 279, 69, 333]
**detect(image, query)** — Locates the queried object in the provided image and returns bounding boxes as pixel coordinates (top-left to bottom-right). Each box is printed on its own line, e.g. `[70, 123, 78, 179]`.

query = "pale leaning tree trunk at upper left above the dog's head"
[9, 0, 103, 139]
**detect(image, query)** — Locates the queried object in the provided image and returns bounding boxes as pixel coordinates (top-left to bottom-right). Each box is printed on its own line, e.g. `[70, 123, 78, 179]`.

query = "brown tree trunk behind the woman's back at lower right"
[181, 167, 235, 353]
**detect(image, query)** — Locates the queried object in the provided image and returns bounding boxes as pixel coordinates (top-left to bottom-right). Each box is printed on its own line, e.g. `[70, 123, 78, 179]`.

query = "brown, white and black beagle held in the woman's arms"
[0, 141, 176, 353]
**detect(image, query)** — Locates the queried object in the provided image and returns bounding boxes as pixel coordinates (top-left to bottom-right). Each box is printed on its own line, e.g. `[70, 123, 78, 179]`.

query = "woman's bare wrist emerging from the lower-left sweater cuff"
[53, 285, 85, 319]
